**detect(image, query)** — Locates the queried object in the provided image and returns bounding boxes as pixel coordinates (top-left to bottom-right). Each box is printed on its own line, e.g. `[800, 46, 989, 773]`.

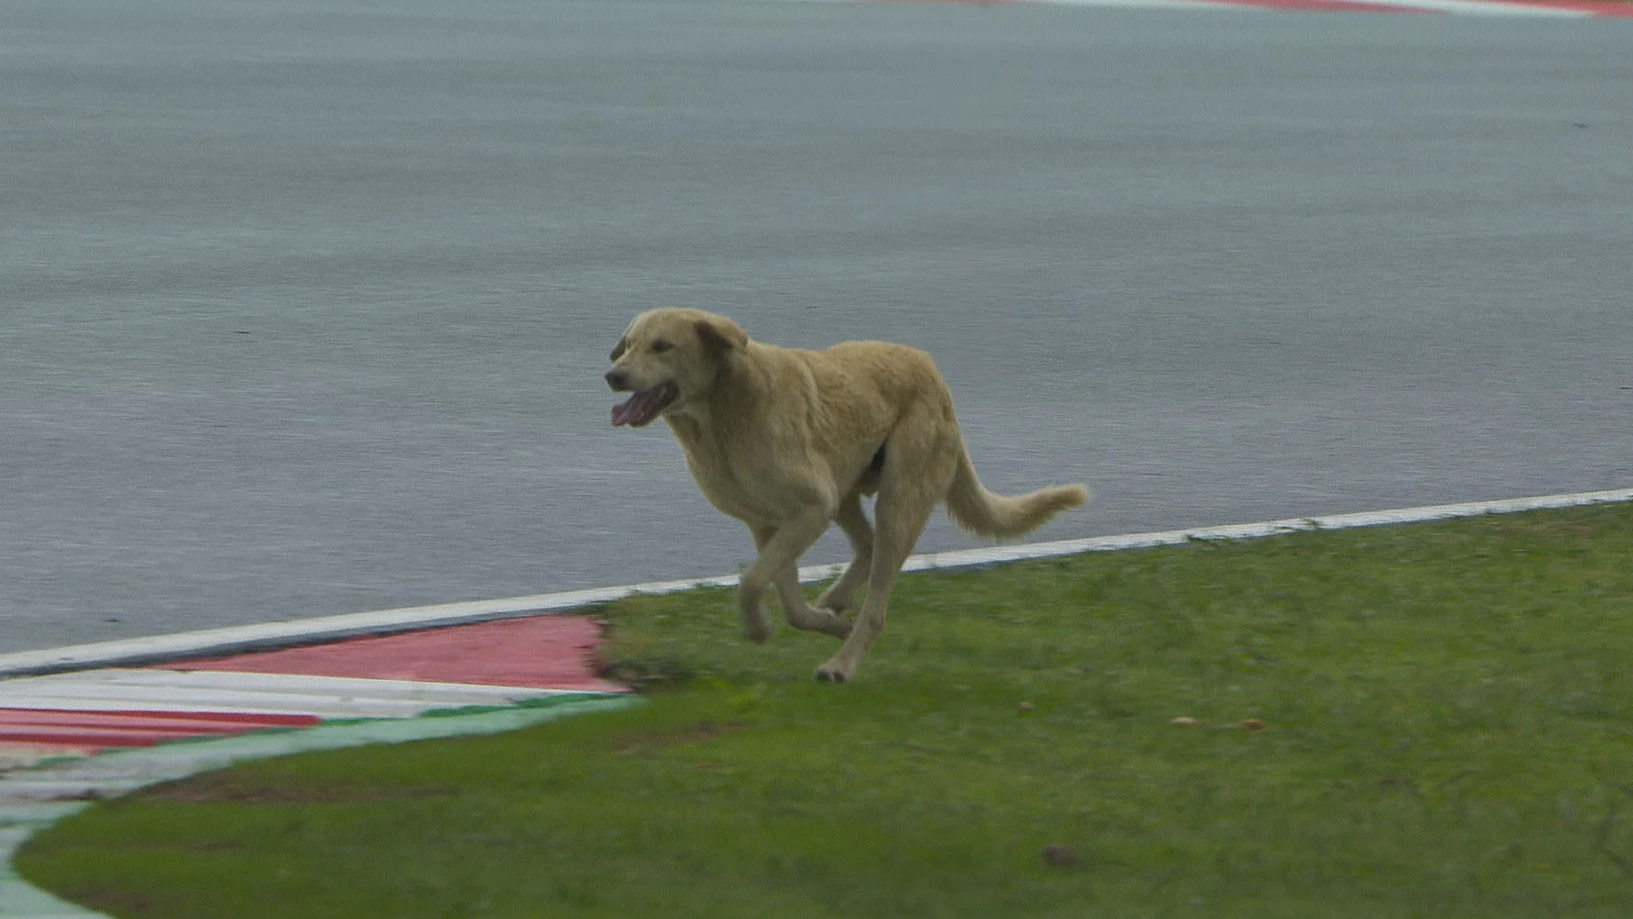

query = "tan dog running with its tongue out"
[606, 309, 1089, 682]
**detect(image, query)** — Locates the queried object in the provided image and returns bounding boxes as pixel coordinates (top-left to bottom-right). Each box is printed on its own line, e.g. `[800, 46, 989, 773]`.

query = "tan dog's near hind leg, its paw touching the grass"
[817, 416, 959, 682]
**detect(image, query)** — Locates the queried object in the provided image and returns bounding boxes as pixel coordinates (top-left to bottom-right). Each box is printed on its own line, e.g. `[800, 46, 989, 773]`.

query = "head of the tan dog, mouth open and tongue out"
[606, 309, 748, 428]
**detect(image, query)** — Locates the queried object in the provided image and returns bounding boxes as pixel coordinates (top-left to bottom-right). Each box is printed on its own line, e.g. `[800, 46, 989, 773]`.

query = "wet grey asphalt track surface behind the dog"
[0, 0, 1633, 651]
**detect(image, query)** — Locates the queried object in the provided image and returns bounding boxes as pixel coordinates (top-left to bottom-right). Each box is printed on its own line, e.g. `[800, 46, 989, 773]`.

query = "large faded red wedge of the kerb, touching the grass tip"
[163, 615, 627, 692]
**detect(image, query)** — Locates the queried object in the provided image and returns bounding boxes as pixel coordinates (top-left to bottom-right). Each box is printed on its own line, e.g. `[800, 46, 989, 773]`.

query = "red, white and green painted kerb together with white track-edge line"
[0, 488, 1633, 919]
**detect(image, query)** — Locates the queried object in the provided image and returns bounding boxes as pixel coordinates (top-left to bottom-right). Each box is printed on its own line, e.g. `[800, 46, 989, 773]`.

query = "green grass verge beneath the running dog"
[18, 504, 1633, 919]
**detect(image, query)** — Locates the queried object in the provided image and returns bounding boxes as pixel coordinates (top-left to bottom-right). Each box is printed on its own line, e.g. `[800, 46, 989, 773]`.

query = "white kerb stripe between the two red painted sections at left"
[0, 669, 581, 718]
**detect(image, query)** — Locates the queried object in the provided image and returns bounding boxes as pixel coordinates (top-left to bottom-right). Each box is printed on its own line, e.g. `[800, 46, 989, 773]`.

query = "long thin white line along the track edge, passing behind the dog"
[0, 488, 1633, 677]
